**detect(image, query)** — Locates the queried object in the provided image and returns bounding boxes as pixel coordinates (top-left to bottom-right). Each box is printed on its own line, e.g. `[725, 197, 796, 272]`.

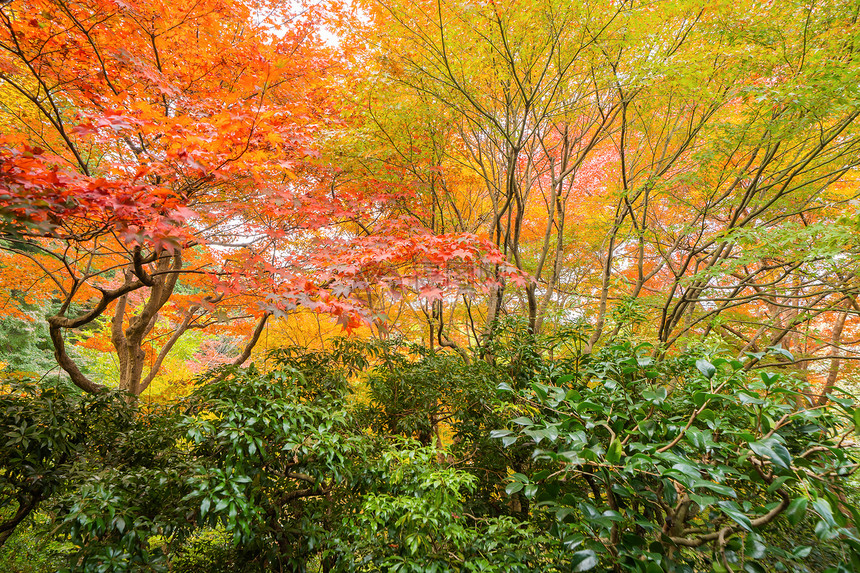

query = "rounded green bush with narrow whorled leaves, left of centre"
[181, 366, 369, 567]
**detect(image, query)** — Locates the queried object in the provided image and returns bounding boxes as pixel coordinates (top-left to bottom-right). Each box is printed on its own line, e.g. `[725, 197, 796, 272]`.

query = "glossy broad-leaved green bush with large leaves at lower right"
[494, 344, 860, 573]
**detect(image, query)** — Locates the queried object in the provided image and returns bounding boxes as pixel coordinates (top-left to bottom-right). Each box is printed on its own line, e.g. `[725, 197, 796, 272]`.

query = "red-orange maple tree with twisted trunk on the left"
[0, 0, 510, 395]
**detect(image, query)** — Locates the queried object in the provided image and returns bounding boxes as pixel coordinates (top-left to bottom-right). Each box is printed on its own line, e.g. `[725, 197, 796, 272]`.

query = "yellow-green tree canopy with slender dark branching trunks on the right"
[342, 0, 858, 398]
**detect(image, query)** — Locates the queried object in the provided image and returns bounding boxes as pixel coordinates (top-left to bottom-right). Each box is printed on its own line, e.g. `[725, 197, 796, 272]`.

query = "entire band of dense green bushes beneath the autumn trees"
[0, 327, 860, 573]
